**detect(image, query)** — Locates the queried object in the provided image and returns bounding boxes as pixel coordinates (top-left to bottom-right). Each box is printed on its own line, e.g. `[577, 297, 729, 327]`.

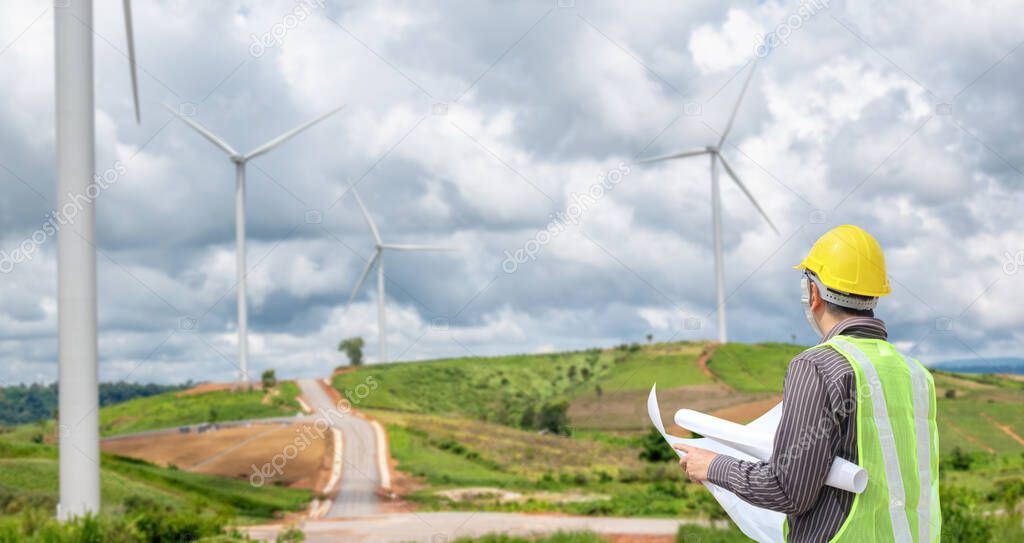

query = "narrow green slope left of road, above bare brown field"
[99, 381, 300, 435]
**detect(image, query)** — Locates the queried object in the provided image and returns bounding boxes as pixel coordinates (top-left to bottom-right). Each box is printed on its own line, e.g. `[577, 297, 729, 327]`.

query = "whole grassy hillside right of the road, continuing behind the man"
[334, 343, 1024, 524]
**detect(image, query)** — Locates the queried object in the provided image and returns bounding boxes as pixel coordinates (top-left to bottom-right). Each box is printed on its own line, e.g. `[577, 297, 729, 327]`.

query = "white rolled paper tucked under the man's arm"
[675, 403, 867, 494]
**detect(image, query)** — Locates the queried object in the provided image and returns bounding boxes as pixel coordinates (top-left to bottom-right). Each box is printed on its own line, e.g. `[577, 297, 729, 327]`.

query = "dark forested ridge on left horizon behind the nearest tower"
[0, 381, 191, 424]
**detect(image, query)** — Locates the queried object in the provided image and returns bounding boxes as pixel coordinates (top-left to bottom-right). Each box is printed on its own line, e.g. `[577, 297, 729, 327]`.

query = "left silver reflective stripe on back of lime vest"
[830, 338, 913, 543]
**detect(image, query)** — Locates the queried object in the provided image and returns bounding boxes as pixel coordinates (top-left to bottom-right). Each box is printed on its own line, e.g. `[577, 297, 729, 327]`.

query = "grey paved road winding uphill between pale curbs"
[298, 379, 381, 518]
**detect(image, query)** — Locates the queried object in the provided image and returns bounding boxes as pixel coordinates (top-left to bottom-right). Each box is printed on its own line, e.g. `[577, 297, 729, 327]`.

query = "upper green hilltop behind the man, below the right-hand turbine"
[334, 342, 1024, 453]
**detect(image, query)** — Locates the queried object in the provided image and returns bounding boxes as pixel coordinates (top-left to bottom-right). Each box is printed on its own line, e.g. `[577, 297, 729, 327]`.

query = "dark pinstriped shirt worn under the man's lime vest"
[708, 317, 887, 543]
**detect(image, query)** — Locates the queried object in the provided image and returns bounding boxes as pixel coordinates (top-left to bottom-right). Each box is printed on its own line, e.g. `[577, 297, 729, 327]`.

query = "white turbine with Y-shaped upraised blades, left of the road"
[164, 103, 344, 386]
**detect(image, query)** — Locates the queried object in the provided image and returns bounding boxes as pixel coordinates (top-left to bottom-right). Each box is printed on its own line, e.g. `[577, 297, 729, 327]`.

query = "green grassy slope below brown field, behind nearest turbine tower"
[0, 423, 311, 521]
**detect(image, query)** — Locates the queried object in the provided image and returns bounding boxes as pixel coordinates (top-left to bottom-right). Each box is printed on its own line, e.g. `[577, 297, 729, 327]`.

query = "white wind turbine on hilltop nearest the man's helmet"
[637, 60, 778, 343]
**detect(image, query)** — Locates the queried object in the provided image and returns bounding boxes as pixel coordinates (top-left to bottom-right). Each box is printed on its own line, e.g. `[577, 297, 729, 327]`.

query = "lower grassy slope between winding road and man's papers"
[370, 411, 722, 517]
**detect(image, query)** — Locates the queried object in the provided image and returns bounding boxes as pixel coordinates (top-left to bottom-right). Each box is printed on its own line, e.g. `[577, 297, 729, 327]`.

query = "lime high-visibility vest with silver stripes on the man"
[782, 335, 941, 543]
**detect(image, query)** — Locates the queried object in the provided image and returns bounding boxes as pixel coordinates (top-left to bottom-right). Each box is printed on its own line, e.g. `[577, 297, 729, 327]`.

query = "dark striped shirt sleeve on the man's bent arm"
[708, 357, 837, 514]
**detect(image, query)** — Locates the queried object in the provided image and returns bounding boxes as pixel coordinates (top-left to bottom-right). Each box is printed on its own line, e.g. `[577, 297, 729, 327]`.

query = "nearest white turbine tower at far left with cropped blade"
[53, 0, 140, 519]
